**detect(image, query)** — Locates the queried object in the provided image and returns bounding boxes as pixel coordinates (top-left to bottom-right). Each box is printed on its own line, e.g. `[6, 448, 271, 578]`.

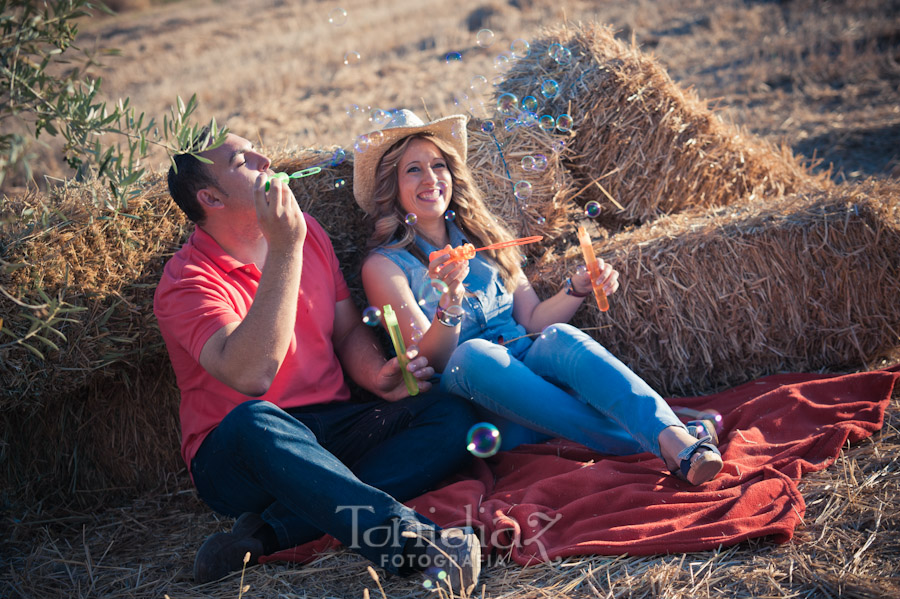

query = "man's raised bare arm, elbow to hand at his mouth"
[200, 177, 306, 397]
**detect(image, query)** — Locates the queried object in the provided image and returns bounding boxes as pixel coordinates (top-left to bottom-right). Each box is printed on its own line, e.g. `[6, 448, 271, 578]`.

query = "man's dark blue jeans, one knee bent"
[191, 388, 476, 572]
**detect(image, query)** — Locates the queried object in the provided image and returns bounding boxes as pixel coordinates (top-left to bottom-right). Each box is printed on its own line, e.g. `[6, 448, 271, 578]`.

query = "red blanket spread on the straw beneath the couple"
[261, 371, 900, 565]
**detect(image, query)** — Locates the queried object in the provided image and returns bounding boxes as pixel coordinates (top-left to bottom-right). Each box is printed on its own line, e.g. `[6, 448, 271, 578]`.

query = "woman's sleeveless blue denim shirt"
[373, 222, 531, 357]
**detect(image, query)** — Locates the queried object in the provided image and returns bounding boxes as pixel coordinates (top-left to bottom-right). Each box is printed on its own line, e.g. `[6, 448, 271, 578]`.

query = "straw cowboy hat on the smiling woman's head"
[353, 108, 468, 214]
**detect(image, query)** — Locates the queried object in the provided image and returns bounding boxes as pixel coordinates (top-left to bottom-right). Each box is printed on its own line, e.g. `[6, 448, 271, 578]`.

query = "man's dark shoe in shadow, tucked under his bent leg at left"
[194, 512, 266, 584]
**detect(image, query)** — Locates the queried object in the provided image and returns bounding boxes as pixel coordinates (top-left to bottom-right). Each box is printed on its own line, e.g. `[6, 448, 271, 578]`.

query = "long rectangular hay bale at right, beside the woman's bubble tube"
[542, 182, 900, 395]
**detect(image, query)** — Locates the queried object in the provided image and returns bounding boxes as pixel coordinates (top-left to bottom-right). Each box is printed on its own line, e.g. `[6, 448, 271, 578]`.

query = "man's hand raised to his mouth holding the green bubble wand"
[253, 173, 306, 252]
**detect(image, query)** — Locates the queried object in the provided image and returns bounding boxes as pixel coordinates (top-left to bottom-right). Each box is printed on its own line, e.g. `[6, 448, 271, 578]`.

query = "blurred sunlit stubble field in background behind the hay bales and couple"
[8, 0, 900, 190]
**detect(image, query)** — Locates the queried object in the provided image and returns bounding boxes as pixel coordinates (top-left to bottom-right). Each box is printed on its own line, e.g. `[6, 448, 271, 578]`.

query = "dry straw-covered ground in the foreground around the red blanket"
[0, 390, 900, 599]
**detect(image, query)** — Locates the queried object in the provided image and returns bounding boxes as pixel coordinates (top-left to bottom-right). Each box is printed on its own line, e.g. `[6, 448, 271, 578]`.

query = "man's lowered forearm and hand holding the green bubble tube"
[332, 298, 434, 401]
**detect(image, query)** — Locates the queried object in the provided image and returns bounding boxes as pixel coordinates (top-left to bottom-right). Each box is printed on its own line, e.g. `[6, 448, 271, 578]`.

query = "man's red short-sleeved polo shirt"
[153, 214, 350, 469]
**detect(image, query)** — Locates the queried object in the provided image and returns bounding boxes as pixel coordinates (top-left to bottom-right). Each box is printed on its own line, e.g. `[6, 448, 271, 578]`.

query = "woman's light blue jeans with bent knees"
[441, 324, 684, 456]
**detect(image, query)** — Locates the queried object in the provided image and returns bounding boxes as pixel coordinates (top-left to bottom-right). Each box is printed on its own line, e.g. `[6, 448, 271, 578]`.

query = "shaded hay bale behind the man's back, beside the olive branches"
[0, 175, 190, 501]
